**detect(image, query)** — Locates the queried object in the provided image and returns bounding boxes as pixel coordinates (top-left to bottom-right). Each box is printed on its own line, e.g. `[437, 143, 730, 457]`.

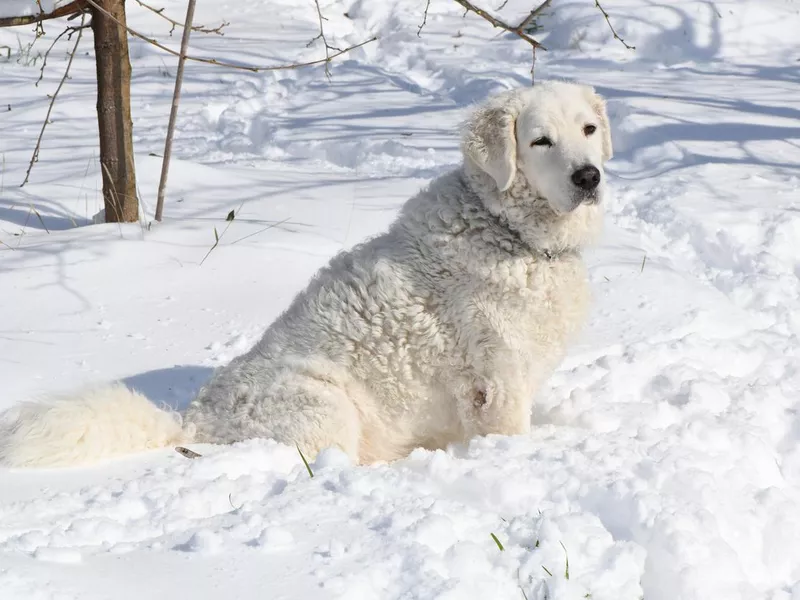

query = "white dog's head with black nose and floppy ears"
[462, 82, 612, 215]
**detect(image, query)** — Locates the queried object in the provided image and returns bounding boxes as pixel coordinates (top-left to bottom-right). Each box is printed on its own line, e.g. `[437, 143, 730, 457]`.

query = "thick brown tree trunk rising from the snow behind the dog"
[91, 0, 139, 223]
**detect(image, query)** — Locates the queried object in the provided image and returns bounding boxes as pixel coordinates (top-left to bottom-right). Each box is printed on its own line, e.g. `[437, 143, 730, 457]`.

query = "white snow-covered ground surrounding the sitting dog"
[0, 0, 800, 600]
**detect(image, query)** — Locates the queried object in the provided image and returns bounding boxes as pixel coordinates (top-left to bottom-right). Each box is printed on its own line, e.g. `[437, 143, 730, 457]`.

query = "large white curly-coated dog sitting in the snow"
[0, 82, 612, 466]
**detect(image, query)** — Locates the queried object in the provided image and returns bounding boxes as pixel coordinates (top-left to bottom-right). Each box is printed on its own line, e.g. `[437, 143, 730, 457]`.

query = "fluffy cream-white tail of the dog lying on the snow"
[0, 383, 192, 467]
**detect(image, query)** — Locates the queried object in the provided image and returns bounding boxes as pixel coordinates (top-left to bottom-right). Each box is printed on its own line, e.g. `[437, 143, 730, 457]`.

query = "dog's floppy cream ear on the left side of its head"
[461, 92, 521, 192]
